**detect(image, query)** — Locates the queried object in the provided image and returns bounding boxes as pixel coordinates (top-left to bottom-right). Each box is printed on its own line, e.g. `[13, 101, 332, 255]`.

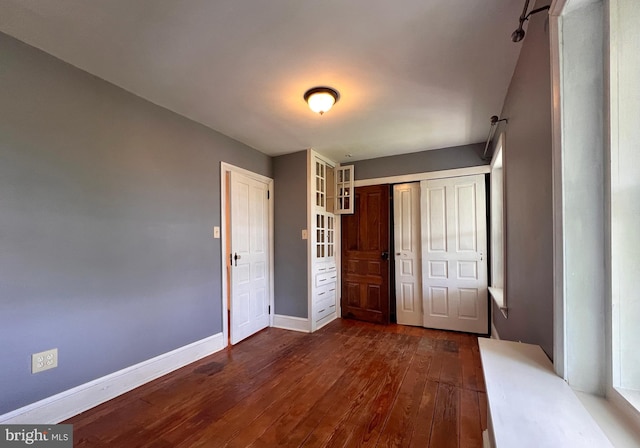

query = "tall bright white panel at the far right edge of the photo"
[610, 0, 640, 390]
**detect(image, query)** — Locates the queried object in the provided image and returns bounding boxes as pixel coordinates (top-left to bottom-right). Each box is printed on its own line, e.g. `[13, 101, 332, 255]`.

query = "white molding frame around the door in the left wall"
[220, 162, 275, 347]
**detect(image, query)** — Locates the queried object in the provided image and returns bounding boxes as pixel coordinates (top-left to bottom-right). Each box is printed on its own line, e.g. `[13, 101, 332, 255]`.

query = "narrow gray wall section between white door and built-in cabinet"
[273, 151, 308, 318]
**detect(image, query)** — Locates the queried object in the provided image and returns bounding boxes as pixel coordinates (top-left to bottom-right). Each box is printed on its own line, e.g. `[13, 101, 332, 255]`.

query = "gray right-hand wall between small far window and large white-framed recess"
[493, 2, 553, 357]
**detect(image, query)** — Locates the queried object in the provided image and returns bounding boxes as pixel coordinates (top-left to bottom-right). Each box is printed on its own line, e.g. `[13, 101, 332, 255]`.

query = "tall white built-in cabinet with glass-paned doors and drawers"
[308, 150, 354, 331]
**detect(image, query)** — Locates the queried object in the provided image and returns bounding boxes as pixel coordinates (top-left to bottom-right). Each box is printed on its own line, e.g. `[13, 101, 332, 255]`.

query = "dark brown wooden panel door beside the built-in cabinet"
[341, 185, 390, 324]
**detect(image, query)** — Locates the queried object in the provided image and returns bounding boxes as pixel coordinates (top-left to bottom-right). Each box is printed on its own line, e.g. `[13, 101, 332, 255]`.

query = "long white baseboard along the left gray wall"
[0, 333, 224, 425]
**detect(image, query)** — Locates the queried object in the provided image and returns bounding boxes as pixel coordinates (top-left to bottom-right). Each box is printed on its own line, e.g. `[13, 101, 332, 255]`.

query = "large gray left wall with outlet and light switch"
[0, 34, 272, 414]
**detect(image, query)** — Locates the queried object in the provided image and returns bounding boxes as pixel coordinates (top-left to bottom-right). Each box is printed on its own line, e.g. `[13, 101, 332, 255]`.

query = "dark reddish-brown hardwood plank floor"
[65, 319, 487, 448]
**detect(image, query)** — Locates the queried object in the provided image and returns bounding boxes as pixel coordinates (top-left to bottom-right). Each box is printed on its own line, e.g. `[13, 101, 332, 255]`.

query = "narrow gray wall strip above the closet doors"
[344, 143, 490, 180]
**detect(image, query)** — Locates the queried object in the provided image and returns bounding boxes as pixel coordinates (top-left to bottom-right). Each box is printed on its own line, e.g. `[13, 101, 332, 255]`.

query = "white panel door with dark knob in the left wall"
[230, 171, 270, 344]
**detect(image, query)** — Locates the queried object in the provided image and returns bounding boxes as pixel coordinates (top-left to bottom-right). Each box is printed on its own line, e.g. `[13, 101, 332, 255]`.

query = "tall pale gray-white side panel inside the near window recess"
[556, 1, 606, 395]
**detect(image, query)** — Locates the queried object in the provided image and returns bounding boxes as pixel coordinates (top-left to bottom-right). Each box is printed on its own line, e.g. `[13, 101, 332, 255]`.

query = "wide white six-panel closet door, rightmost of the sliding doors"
[420, 175, 489, 334]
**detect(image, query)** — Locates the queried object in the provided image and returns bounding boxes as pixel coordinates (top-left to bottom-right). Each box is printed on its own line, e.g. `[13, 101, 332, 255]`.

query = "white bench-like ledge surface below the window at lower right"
[478, 338, 612, 448]
